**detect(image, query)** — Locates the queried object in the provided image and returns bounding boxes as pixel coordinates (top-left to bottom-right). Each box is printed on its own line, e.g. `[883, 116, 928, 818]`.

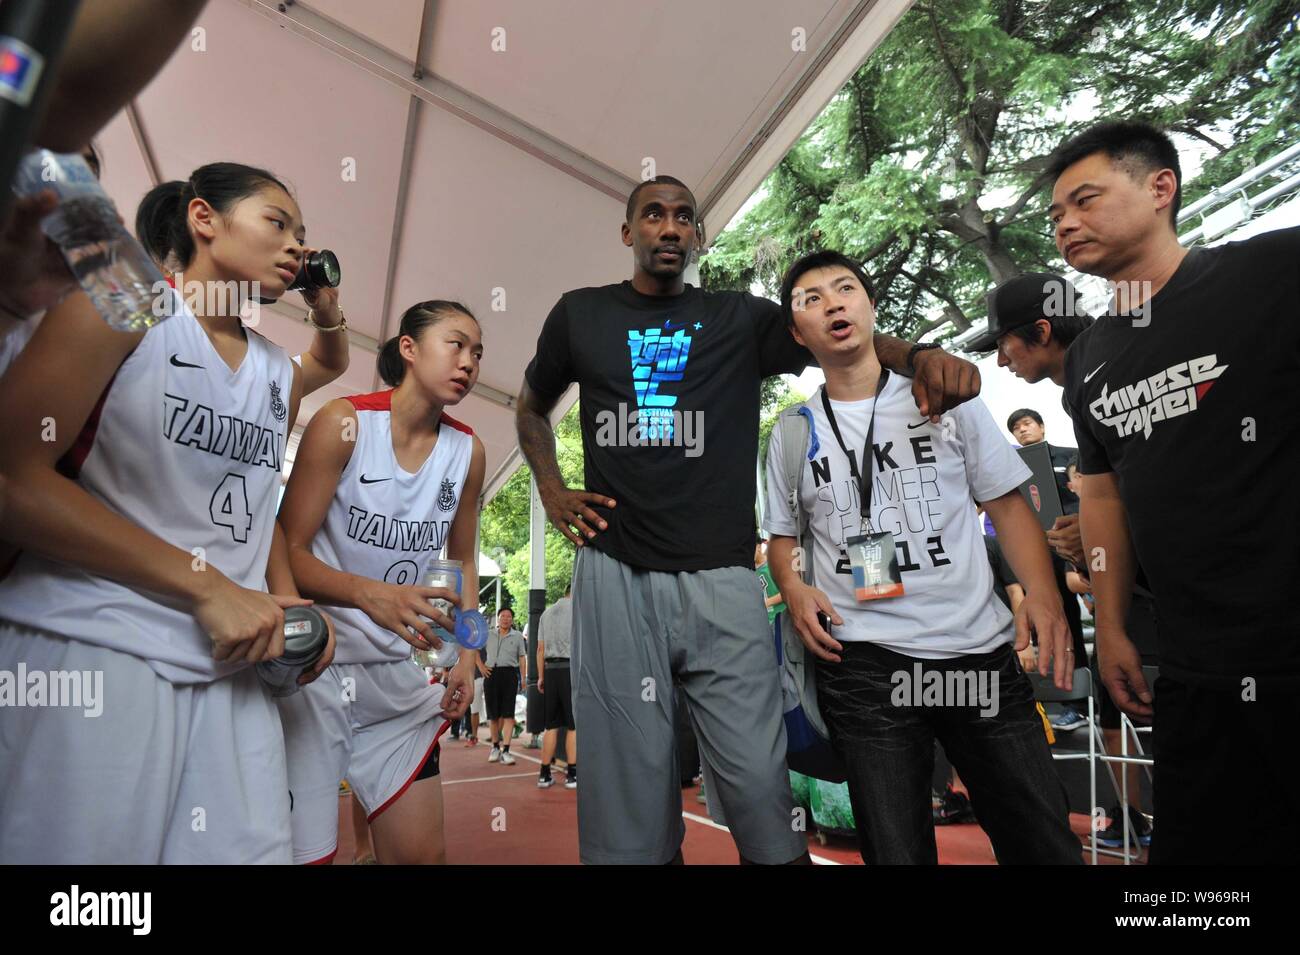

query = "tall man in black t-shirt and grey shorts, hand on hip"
[517, 177, 979, 864]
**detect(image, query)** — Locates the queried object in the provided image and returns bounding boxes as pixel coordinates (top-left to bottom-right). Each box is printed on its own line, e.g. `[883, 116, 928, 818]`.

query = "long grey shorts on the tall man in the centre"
[571, 547, 807, 864]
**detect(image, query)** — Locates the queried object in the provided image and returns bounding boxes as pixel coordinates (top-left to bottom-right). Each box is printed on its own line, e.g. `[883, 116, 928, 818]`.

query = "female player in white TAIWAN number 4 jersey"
[0, 164, 333, 863]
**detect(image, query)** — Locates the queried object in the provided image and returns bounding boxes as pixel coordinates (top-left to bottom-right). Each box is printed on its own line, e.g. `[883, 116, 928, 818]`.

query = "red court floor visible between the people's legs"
[334, 730, 1145, 865]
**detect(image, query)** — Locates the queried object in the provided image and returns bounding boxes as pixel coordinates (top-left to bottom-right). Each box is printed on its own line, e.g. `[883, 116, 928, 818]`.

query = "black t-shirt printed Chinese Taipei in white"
[1066, 229, 1300, 685]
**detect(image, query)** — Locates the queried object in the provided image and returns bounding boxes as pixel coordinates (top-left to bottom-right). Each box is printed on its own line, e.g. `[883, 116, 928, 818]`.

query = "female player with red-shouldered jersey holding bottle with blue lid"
[280, 301, 485, 864]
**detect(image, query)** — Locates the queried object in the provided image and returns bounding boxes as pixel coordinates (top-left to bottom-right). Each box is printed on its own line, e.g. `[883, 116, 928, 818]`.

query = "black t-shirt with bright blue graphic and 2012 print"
[524, 282, 811, 572]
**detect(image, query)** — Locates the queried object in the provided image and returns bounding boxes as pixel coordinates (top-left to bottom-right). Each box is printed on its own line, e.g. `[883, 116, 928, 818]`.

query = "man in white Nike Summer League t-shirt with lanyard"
[766, 252, 1082, 864]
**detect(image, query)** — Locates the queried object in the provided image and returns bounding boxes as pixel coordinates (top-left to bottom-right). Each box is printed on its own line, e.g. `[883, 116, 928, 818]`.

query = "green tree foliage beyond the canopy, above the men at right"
[703, 0, 1300, 338]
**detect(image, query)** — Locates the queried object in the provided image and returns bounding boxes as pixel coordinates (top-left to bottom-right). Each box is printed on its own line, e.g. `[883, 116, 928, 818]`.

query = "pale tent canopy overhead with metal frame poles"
[100, 0, 910, 509]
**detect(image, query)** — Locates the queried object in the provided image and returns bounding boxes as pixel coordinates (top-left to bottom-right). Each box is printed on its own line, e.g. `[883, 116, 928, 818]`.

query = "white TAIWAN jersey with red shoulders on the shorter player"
[312, 388, 476, 663]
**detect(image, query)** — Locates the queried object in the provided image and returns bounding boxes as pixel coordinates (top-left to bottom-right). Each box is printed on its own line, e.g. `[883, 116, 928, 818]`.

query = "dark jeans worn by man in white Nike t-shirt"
[816, 643, 1083, 865]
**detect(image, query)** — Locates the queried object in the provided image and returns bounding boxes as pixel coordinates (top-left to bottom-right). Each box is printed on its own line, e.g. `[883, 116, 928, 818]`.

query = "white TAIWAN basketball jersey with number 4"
[0, 302, 294, 682]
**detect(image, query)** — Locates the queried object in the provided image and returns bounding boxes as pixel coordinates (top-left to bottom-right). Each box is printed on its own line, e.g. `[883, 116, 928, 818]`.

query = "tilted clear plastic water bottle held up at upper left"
[13, 149, 176, 331]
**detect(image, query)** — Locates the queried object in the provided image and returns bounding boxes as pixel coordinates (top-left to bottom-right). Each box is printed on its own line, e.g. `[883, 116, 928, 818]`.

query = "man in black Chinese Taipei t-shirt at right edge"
[1049, 122, 1300, 864]
